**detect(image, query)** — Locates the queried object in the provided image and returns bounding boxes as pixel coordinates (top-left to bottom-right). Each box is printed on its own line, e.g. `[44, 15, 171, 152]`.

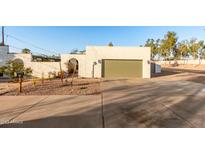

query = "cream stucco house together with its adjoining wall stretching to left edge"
[0, 46, 151, 78]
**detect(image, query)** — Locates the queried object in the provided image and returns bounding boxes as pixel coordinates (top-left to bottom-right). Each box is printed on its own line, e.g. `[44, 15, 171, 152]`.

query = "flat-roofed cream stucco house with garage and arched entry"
[61, 46, 151, 78]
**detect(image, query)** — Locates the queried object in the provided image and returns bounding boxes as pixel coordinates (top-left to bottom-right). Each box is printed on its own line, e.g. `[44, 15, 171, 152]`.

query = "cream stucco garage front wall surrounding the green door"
[86, 46, 150, 78]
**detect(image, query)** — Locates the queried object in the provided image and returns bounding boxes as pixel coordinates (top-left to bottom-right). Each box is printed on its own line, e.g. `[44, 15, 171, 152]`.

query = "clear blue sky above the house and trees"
[2, 26, 205, 54]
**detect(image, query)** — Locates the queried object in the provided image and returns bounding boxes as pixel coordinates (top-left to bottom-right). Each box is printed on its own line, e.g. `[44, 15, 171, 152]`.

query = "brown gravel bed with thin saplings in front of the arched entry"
[3, 79, 100, 96]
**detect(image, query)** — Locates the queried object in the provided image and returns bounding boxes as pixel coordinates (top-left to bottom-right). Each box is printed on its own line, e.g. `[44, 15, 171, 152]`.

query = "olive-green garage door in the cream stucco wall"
[102, 59, 142, 78]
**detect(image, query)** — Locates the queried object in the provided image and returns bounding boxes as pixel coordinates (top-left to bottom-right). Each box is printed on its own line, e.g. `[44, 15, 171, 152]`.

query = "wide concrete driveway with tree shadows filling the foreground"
[0, 67, 205, 128]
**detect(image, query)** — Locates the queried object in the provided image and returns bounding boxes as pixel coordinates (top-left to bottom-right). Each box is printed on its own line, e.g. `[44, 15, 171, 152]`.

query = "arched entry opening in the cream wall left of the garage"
[67, 58, 79, 77]
